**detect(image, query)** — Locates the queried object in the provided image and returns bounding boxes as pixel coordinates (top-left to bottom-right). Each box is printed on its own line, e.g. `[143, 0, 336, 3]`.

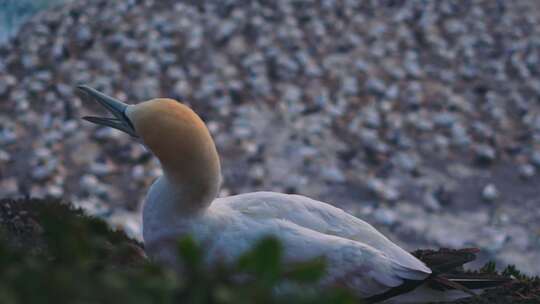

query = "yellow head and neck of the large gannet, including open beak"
[79, 86, 221, 207]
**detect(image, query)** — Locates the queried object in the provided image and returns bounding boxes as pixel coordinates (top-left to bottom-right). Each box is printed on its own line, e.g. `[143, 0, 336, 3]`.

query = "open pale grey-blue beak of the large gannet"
[77, 85, 138, 138]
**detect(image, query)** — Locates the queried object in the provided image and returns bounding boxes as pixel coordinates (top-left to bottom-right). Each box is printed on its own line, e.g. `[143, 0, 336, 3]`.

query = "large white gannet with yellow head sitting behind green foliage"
[78, 86, 506, 300]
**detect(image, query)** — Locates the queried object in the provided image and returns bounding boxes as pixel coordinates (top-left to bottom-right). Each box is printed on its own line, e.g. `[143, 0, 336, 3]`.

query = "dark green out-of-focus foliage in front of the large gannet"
[0, 200, 358, 304]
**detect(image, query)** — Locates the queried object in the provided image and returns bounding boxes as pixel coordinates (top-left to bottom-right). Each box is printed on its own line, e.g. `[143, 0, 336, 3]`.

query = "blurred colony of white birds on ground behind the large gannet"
[0, 0, 540, 274]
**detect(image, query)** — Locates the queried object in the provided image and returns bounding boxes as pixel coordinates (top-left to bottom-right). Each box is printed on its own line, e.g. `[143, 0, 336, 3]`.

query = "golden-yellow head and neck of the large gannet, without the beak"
[134, 99, 221, 215]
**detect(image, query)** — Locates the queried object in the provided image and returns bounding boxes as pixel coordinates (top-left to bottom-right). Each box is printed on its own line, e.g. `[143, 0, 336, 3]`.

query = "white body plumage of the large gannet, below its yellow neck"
[143, 177, 431, 297]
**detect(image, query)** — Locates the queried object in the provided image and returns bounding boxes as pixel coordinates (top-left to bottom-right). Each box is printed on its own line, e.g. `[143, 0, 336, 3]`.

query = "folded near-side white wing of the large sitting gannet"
[209, 215, 427, 297]
